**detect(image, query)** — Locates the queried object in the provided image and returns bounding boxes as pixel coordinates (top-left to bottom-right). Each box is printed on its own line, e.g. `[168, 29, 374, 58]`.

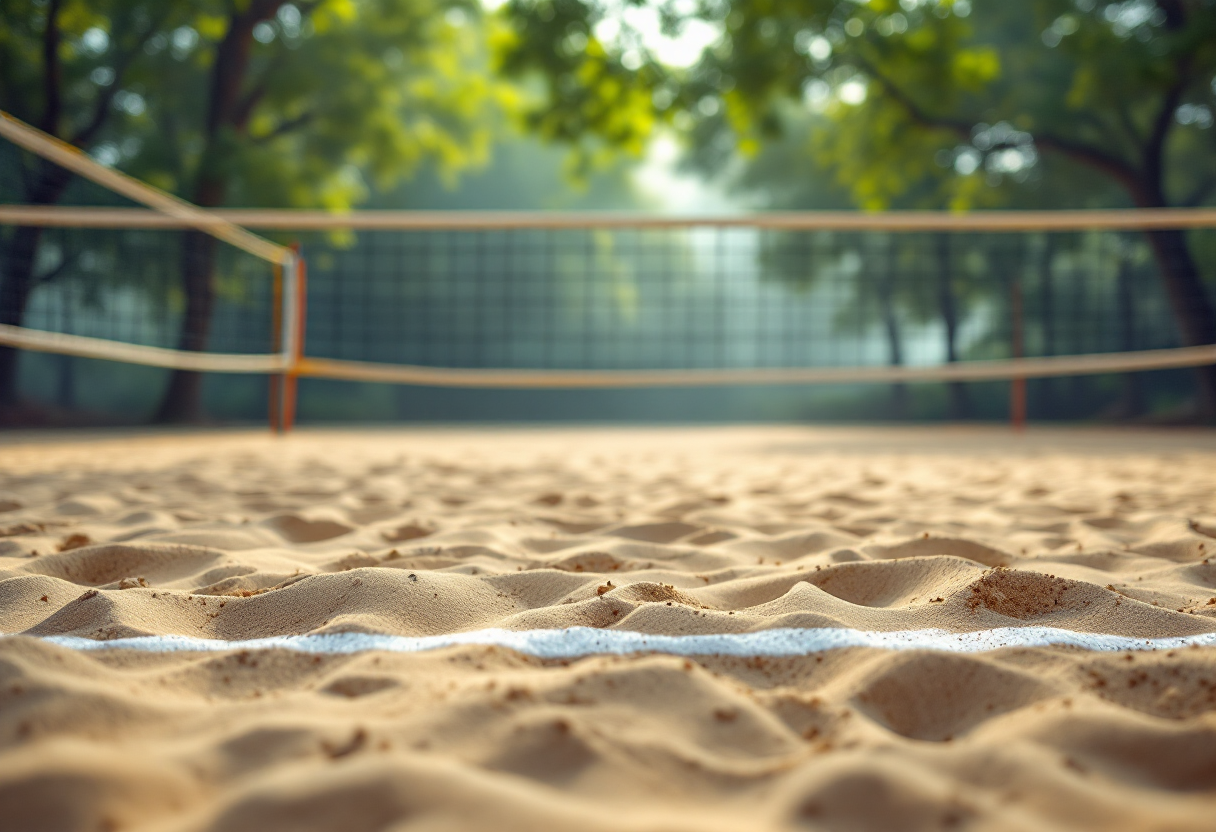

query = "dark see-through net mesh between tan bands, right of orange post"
[304, 227, 1201, 370]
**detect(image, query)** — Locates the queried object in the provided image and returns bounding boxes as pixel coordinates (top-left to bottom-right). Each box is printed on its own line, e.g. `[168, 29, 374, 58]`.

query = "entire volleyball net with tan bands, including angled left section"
[0, 110, 1216, 427]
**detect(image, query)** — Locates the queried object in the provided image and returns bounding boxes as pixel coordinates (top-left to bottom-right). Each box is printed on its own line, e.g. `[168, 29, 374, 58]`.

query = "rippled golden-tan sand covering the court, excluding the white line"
[0, 427, 1216, 832]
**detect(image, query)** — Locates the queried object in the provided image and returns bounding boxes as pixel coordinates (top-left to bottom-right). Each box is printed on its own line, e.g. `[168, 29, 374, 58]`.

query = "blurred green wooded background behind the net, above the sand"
[0, 0, 1216, 427]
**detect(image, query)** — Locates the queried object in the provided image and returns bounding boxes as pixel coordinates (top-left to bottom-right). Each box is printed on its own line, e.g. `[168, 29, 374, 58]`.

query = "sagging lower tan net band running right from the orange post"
[293, 344, 1216, 389]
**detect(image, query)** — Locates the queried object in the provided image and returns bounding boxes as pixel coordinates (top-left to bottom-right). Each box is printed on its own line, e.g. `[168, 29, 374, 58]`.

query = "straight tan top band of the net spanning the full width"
[0, 206, 1216, 232]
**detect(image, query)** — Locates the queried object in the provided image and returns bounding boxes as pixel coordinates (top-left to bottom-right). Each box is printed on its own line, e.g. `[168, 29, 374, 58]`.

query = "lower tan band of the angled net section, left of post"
[0, 324, 289, 373]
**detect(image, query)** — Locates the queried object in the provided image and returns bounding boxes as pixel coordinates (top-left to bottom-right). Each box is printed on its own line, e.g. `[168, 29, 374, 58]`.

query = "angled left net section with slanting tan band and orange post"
[0, 112, 303, 427]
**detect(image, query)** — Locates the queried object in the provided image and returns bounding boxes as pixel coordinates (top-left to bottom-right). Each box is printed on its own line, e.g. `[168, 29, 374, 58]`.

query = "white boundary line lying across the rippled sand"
[14, 626, 1216, 659]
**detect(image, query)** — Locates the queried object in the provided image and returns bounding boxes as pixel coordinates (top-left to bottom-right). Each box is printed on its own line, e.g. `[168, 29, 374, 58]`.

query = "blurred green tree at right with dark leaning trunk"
[493, 0, 1216, 415]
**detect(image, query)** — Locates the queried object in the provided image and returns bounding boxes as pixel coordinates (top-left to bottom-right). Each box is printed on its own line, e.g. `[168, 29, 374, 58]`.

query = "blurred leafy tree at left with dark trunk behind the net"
[0, 0, 506, 421]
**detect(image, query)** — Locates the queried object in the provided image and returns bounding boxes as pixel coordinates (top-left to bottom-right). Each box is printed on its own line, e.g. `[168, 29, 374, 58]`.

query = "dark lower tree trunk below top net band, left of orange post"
[156, 231, 216, 423]
